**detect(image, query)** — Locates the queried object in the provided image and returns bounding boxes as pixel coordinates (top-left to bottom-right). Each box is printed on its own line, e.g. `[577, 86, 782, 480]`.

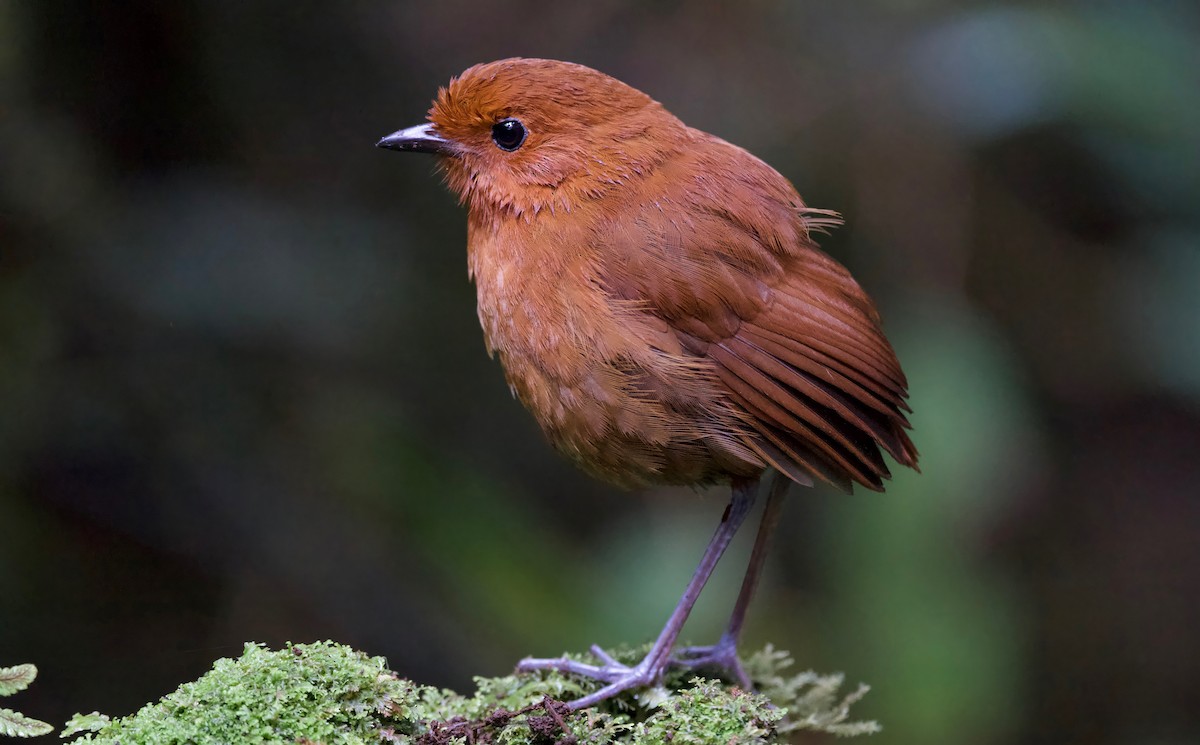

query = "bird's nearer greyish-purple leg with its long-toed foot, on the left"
[517, 479, 758, 709]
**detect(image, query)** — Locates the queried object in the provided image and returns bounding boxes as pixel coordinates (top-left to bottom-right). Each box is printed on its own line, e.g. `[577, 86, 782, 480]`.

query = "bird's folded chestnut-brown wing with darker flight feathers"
[602, 138, 917, 491]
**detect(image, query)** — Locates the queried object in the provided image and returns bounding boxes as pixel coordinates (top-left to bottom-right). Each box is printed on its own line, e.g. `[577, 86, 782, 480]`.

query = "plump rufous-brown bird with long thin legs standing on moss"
[377, 58, 918, 709]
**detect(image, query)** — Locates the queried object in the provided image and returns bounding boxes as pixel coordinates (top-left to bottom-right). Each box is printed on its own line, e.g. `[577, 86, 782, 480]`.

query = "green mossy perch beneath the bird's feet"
[62, 642, 878, 745]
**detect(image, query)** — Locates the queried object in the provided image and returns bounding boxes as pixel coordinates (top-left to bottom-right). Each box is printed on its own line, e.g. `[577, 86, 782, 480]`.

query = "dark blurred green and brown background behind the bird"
[0, 0, 1200, 745]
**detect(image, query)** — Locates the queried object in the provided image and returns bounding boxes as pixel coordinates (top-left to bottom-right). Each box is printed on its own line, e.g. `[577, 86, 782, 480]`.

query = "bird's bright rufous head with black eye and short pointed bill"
[379, 58, 688, 217]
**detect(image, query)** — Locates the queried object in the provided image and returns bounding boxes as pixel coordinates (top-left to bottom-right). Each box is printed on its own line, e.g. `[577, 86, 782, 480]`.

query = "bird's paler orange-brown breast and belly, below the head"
[468, 213, 754, 486]
